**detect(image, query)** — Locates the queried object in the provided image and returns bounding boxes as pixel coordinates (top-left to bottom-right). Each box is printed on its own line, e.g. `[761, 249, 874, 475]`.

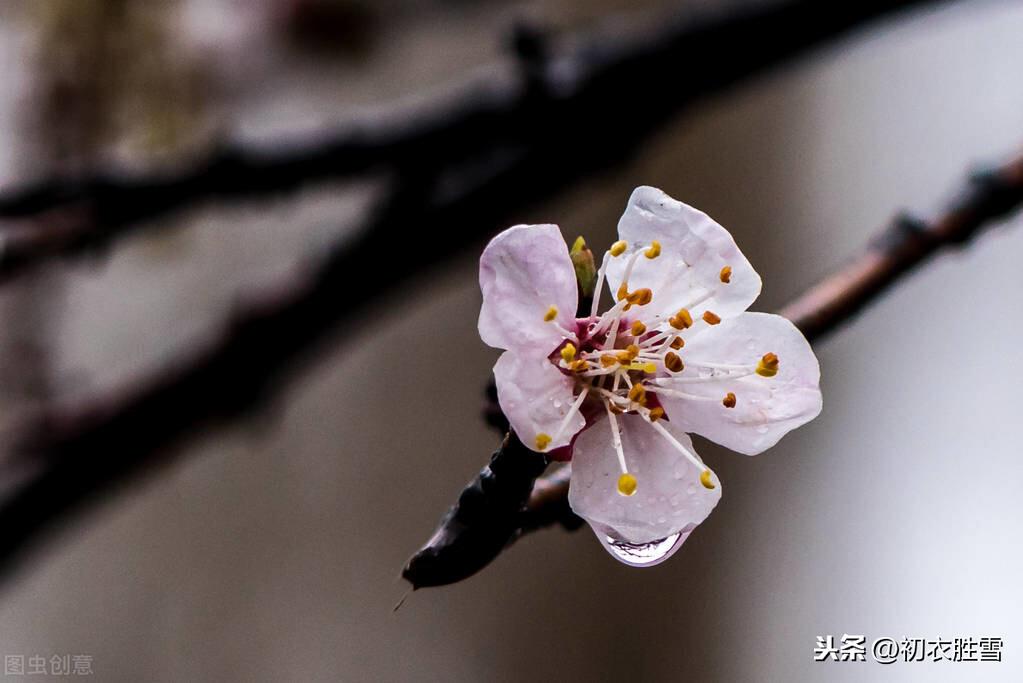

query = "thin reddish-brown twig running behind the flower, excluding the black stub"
[517, 154, 1023, 538]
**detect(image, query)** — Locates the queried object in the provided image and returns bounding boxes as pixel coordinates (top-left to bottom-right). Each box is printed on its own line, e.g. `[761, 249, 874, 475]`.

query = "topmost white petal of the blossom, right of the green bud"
[607, 187, 760, 320]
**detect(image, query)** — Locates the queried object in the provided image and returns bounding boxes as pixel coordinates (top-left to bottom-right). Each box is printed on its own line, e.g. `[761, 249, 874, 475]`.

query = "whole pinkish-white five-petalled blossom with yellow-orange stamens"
[480, 187, 820, 554]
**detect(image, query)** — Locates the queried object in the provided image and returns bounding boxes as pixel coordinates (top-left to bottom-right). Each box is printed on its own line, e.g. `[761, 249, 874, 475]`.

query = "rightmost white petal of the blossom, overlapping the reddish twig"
[658, 313, 820, 455]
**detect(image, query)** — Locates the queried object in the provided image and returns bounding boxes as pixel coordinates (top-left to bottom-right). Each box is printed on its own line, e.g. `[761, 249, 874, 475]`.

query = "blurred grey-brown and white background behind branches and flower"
[0, 0, 1023, 681]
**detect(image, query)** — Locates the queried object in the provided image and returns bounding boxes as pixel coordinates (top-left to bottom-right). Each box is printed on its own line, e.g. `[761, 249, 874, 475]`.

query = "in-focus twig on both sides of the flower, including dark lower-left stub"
[402, 154, 1023, 589]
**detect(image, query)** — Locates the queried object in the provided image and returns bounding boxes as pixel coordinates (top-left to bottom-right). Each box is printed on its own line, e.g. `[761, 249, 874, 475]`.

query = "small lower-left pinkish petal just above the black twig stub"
[494, 351, 586, 452]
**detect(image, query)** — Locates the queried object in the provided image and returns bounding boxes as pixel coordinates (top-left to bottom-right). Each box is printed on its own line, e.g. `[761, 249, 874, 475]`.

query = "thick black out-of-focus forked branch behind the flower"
[0, 0, 990, 588]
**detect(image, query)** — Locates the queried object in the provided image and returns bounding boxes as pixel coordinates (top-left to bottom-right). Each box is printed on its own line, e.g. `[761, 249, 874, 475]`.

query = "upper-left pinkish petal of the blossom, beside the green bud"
[480, 225, 578, 355]
